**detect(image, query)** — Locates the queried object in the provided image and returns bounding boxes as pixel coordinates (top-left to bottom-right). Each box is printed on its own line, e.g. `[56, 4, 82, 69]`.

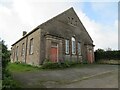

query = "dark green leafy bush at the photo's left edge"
[0, 41, 18, 89]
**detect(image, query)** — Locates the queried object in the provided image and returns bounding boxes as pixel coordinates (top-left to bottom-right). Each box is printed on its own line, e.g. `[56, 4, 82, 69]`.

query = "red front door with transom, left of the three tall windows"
[50, 43, 58, 62]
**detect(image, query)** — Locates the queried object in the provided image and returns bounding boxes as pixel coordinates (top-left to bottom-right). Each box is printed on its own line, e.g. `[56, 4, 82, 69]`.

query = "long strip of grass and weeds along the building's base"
[7, 63, 96, 73]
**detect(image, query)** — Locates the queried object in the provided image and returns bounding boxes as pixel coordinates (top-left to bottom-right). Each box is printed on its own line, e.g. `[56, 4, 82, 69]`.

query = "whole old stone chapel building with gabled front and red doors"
[11, 8, 94, 65]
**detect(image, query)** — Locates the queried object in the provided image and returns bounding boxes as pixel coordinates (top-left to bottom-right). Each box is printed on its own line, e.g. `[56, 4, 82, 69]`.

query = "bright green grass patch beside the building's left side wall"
[7, 63, 40, 72]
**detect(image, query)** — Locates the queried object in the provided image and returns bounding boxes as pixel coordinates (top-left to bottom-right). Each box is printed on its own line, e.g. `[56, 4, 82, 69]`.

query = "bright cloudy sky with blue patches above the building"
[0, 0, 118, 50]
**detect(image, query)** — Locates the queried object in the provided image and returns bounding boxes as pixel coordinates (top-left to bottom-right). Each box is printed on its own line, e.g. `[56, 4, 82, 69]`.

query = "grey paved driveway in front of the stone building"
[13, 64, 118, 88]
